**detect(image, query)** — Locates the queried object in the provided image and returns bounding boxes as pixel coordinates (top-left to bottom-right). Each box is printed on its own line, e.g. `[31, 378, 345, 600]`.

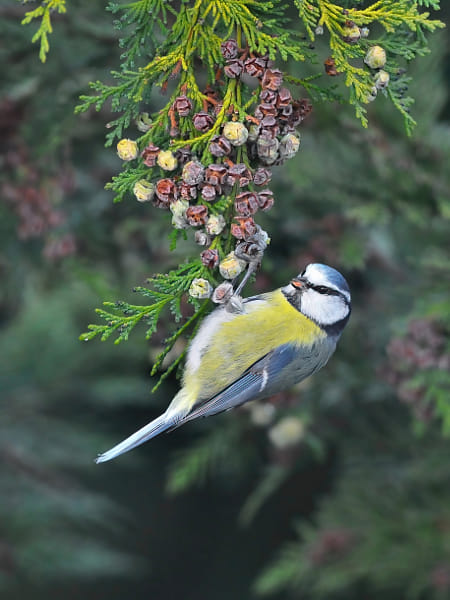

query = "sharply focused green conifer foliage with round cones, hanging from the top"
[18, 0, 442, 382]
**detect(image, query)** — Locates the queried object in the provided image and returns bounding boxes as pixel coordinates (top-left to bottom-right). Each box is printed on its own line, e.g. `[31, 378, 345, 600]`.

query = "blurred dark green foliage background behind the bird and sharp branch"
[0, 0, 450, 600]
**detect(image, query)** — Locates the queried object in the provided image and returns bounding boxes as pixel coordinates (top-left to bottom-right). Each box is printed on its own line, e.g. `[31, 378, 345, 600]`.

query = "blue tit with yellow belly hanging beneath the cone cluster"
[96, 263, 351, 463]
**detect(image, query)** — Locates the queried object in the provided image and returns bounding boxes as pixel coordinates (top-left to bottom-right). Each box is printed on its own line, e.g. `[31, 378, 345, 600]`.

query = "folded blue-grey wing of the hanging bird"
[180, 344, 298, 425]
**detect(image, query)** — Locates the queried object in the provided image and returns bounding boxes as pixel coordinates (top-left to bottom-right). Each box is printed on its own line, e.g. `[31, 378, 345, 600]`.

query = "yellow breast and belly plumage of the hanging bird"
[184, 290, 325, 401]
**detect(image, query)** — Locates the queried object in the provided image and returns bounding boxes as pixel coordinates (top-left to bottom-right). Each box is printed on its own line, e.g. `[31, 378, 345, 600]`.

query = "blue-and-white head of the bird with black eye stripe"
[282, 263, 351, 335]
